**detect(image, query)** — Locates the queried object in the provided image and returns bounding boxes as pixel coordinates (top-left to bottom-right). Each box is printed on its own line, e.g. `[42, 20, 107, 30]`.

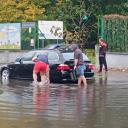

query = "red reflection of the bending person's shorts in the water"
[33, 86, 49, 113]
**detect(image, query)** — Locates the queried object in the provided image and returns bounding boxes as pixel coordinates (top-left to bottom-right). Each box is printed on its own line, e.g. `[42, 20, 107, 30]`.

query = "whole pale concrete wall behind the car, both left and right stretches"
[0, 46, 128, 68]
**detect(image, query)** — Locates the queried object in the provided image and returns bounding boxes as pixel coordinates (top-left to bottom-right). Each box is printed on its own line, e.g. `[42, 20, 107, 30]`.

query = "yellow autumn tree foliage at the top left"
[0, 0, 45, 22]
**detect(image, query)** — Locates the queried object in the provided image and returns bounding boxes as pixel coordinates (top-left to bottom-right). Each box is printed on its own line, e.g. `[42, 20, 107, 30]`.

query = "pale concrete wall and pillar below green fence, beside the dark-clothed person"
[95, 46, 128, 68]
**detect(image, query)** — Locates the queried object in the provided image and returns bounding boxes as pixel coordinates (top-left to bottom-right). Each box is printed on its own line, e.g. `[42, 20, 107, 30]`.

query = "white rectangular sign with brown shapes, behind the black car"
[38, 21, 63, 39]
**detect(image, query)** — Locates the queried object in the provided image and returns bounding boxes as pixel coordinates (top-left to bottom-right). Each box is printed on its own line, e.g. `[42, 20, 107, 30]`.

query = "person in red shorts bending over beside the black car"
[32, 53, 50, 85]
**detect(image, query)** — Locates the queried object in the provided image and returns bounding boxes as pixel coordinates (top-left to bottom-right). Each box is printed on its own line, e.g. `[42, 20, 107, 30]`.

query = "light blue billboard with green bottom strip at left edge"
[0, 23, 21, 49]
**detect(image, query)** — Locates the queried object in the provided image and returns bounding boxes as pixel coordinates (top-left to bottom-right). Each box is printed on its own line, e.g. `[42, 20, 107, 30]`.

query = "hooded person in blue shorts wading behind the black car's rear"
[70, 44, 87, 86]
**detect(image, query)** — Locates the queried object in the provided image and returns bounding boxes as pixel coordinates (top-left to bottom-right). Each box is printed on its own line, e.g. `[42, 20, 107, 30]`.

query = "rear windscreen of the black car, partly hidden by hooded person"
[62, 52, 89, 61]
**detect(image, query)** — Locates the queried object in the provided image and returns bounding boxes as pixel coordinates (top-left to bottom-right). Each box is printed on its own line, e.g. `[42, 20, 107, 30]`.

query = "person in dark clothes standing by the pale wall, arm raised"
[99, 38, 108, 73]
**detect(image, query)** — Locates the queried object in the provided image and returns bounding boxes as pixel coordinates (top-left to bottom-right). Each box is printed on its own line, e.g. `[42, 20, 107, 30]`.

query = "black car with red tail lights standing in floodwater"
[1, 49, 94, 82]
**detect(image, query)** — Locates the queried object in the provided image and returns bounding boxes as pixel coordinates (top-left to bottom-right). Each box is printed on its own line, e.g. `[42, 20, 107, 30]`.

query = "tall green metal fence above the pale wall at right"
[98, 16, 128, 52]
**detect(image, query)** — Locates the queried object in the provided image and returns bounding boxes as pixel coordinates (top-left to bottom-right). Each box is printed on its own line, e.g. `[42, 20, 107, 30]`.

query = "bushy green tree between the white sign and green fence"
[54, 0, 96, 47]
